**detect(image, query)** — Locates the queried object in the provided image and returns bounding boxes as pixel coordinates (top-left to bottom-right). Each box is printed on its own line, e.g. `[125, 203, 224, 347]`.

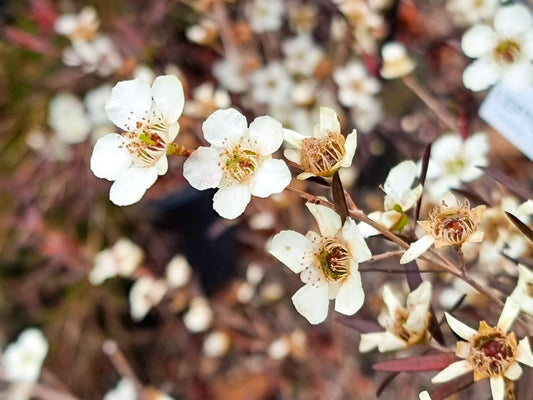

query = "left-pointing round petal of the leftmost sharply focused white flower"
[91, 133, 132, 181]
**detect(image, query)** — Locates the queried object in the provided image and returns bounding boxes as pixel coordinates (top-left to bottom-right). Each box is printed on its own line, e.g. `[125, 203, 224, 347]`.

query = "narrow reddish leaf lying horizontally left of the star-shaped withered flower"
[373, 353, 458, 372]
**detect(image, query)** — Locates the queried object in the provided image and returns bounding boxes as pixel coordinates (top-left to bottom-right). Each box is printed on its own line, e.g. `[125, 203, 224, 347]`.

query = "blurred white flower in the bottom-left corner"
[2, 328, 48, 382]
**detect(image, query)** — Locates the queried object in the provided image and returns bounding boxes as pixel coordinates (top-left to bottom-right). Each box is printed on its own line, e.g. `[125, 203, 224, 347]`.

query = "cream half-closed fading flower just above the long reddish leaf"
[359, 281, 431, 352]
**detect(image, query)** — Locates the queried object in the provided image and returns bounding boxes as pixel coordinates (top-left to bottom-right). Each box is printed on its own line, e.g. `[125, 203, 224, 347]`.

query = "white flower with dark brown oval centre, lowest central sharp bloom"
[269, 203, 372, 324]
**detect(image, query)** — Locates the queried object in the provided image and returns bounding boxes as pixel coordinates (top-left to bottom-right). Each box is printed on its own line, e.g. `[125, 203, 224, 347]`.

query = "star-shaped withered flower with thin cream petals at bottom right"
[431, 299, 533, 400]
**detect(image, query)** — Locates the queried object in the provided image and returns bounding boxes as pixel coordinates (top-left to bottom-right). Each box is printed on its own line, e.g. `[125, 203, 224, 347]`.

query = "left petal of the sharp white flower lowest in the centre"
[268, 231, 314, 273]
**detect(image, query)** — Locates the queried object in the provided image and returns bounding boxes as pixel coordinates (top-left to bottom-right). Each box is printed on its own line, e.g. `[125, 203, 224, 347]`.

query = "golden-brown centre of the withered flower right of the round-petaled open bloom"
[300, 132, 346, 176]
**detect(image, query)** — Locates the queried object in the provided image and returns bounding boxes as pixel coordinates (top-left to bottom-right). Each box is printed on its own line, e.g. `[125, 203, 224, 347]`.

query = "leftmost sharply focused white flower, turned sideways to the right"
[91, 75, 184, 206]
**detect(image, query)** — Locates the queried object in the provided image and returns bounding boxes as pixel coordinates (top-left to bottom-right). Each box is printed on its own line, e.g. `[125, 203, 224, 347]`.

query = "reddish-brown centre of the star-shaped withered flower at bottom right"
[468, 327, 517, 380]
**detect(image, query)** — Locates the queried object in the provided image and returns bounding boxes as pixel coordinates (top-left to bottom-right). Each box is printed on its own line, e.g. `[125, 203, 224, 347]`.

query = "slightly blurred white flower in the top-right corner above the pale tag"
[461, 4, 533, 92]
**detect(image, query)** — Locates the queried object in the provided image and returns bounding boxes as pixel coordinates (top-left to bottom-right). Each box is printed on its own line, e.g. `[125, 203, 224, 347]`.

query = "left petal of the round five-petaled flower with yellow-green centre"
[183, 147, 222, 190]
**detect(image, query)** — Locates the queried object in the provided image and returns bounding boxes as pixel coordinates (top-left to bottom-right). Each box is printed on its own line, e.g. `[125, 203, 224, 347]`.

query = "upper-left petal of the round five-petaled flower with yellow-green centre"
[202, 108, 248, 147]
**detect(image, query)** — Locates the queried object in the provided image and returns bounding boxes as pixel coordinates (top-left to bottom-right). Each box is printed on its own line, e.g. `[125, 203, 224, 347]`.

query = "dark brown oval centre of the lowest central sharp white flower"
[318, 239, 350, 283]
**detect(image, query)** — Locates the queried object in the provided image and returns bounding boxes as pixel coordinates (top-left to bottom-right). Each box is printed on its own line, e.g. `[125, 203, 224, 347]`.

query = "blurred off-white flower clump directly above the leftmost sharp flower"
[63, 35, 123, 76]
